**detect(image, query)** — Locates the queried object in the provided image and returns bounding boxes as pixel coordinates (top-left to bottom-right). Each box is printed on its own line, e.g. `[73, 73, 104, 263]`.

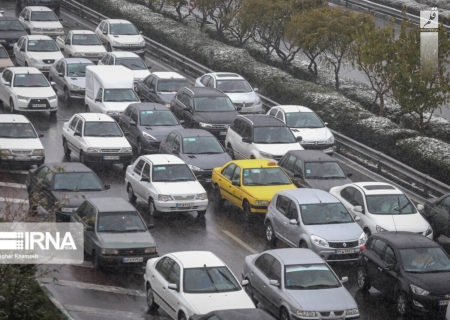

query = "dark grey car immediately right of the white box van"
[135, 71, 191, 107]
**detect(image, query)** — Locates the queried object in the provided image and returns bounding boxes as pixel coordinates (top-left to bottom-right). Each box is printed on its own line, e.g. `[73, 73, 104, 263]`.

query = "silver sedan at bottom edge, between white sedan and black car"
[243, 248, 359, 320]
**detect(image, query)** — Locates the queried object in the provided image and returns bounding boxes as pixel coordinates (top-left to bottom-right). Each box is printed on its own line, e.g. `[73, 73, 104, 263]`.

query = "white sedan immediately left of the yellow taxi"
[125, 154, 208, 217]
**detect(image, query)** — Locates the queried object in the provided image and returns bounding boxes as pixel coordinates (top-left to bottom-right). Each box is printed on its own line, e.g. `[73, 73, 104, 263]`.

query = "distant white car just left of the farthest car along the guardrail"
[56, 30, 106, 63]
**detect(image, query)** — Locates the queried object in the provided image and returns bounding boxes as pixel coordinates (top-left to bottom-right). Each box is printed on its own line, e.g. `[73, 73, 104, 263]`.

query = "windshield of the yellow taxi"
[242, 167, 292, 186]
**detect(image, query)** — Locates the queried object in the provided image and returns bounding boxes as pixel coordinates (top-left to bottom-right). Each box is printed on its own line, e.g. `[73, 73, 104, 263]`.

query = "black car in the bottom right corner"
[357, 231, 450, 315]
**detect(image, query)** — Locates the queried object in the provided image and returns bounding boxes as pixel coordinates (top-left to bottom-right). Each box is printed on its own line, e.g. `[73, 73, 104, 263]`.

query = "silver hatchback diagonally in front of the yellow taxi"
[264, 188, 367, 261]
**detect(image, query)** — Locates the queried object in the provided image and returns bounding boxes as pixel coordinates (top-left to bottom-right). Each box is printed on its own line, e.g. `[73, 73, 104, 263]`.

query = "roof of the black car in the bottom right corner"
[370, 231, 440, 249]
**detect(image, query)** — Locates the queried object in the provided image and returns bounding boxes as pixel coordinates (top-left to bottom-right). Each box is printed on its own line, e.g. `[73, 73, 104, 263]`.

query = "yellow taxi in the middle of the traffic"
[212, 159, 296, 219]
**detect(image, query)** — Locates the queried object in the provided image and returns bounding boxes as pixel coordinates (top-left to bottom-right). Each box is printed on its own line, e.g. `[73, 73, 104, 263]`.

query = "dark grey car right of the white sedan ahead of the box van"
[119, 102, 183, 155]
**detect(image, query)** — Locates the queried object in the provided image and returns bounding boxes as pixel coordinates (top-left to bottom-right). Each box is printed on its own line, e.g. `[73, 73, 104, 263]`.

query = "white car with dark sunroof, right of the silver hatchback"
[330, 181, 433, 239]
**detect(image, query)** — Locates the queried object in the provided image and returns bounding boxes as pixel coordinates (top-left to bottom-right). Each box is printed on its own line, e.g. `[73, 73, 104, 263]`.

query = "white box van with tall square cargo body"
[84, 65, 140, 120]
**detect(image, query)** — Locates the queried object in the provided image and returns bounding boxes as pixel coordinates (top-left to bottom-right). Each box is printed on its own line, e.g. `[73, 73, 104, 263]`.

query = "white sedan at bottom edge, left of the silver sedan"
[144, 251, 255, 320]
